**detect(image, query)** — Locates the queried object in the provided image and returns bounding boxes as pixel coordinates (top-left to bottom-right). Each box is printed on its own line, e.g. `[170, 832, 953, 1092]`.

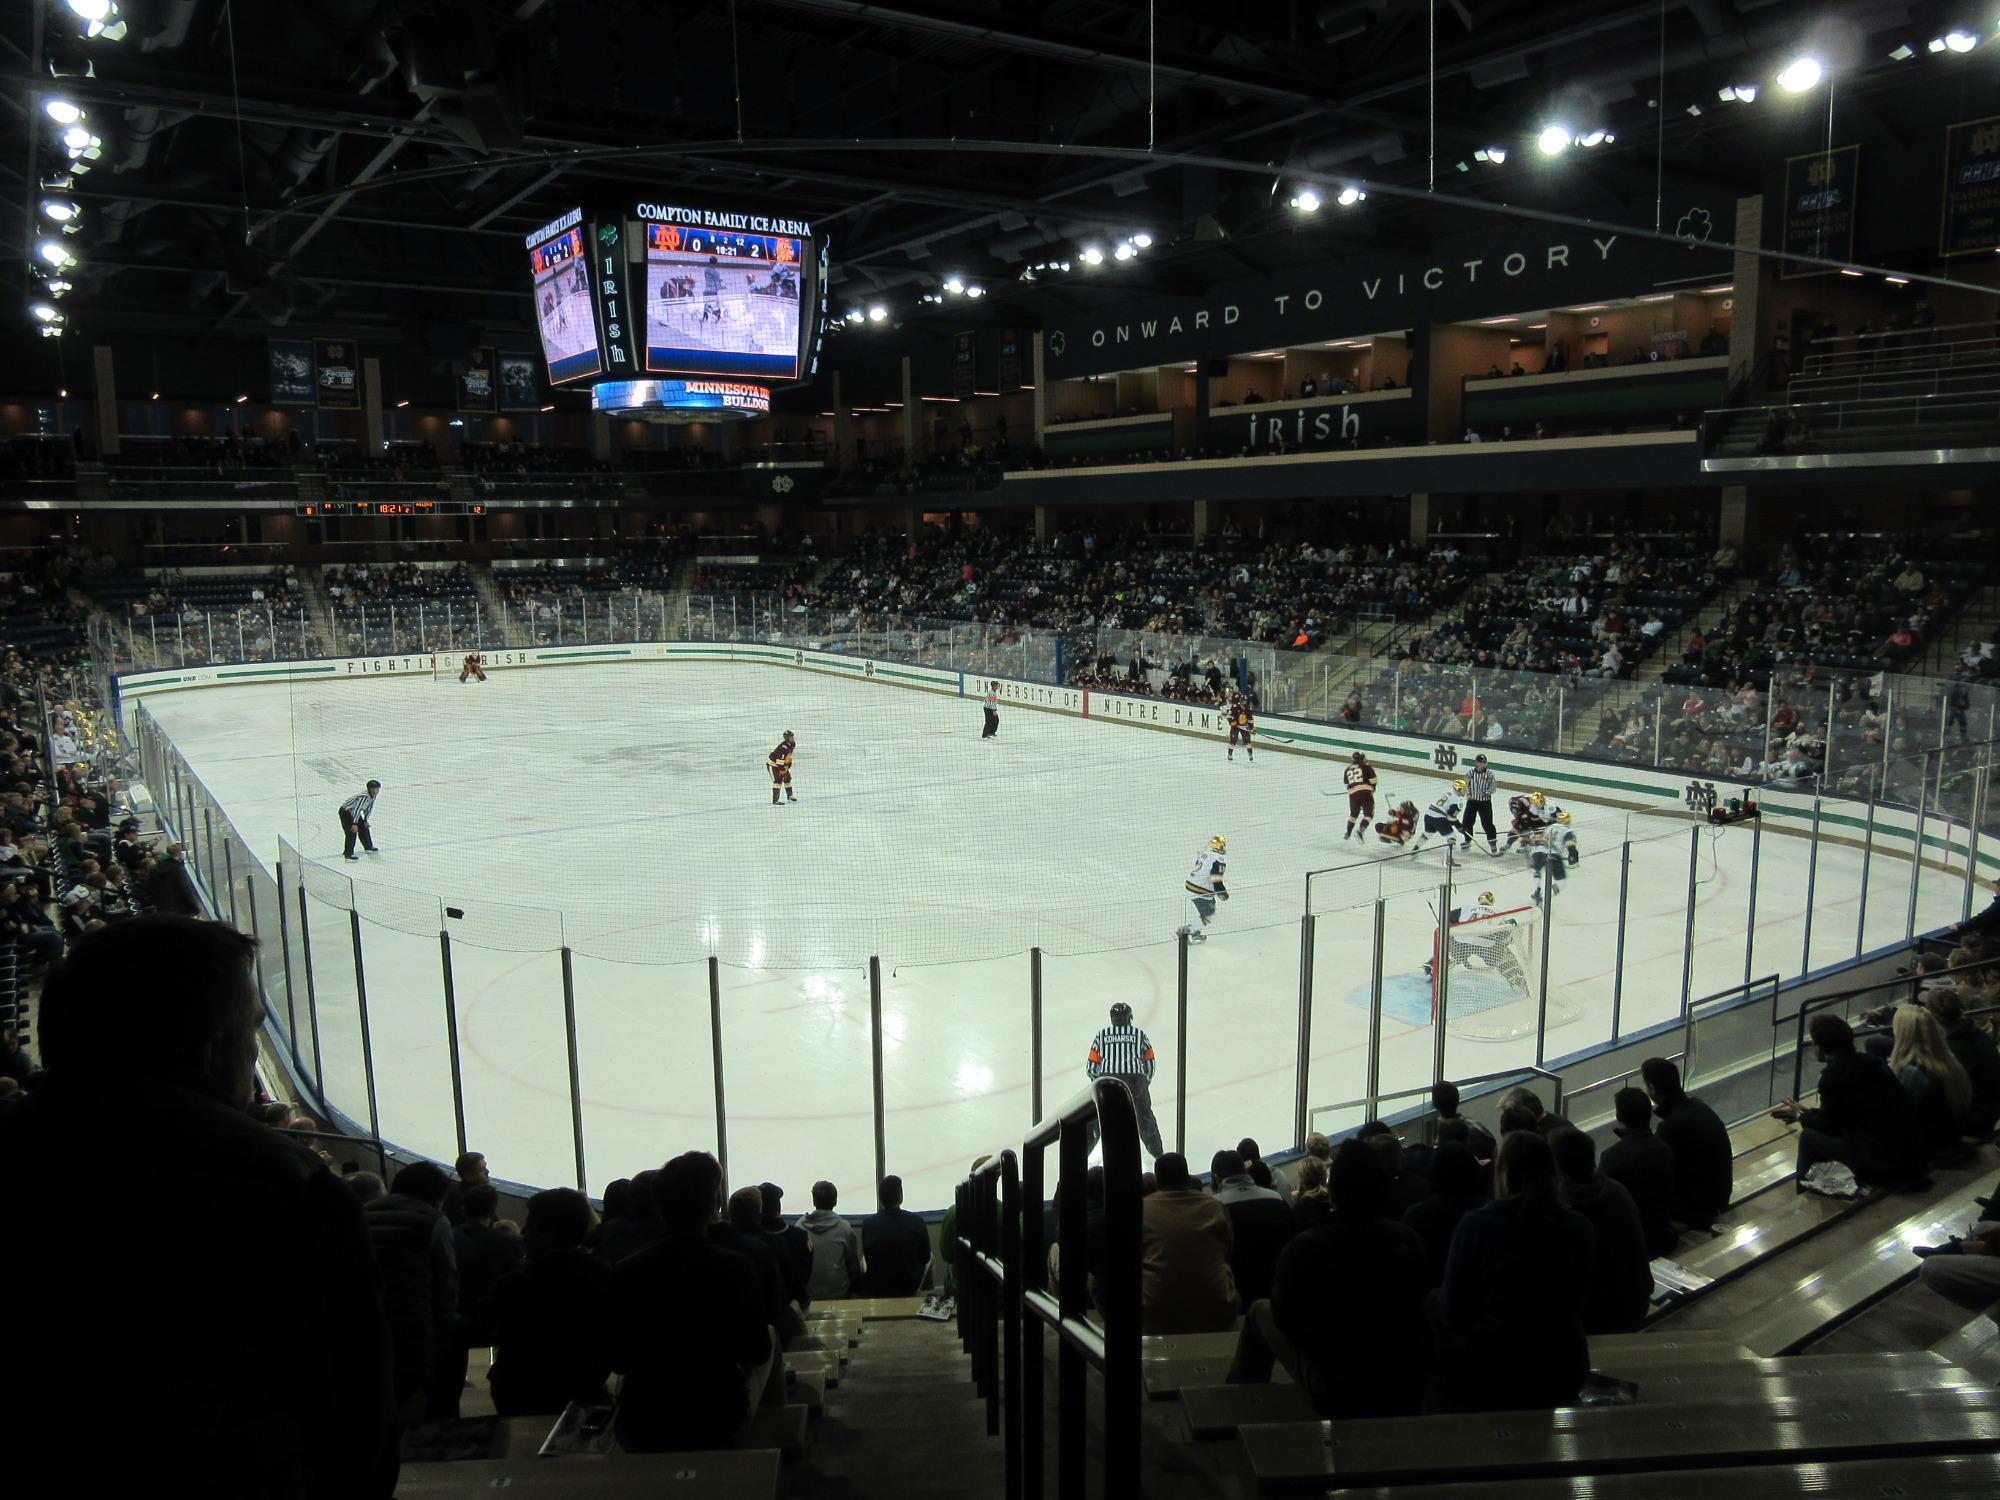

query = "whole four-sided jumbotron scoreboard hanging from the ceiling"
[526, 200, 828, 422]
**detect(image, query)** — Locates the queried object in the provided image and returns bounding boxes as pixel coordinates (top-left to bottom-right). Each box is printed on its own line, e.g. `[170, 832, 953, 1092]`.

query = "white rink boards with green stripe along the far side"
[116, 642, 2000, 872]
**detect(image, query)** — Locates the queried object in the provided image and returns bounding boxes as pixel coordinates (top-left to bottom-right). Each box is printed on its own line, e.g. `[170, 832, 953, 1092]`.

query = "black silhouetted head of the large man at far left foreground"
[38, 914, 262, 1108]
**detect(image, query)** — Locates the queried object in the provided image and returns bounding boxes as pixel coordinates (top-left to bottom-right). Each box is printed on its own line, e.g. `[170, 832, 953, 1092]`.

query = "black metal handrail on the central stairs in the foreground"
[958, 1078, 1144, 1500]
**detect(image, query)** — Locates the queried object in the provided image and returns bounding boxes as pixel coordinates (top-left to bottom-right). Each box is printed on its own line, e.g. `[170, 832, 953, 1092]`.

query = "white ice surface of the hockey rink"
[144, 662, 1964, 1212]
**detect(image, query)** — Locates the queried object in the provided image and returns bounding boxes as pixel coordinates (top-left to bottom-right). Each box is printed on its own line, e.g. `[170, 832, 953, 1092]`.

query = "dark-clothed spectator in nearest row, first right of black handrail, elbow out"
[1228, 1140, 1432, 1418]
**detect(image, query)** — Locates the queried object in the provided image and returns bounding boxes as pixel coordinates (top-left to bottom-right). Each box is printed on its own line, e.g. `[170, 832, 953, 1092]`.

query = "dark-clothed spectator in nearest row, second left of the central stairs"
[472, 1188, 612, 1416]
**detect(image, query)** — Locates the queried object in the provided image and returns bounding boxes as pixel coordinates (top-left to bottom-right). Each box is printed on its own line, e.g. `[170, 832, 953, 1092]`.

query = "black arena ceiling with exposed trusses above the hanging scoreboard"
[0, 0, 2000, 382]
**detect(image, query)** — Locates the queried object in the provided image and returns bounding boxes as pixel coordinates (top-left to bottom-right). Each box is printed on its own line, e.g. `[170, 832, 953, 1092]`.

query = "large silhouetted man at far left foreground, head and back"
[0, 916, 398, 1500]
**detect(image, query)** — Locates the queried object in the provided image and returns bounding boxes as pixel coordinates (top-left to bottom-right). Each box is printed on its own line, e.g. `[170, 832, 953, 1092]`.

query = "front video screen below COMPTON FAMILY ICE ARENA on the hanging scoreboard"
[644, 222, 810, 380]
